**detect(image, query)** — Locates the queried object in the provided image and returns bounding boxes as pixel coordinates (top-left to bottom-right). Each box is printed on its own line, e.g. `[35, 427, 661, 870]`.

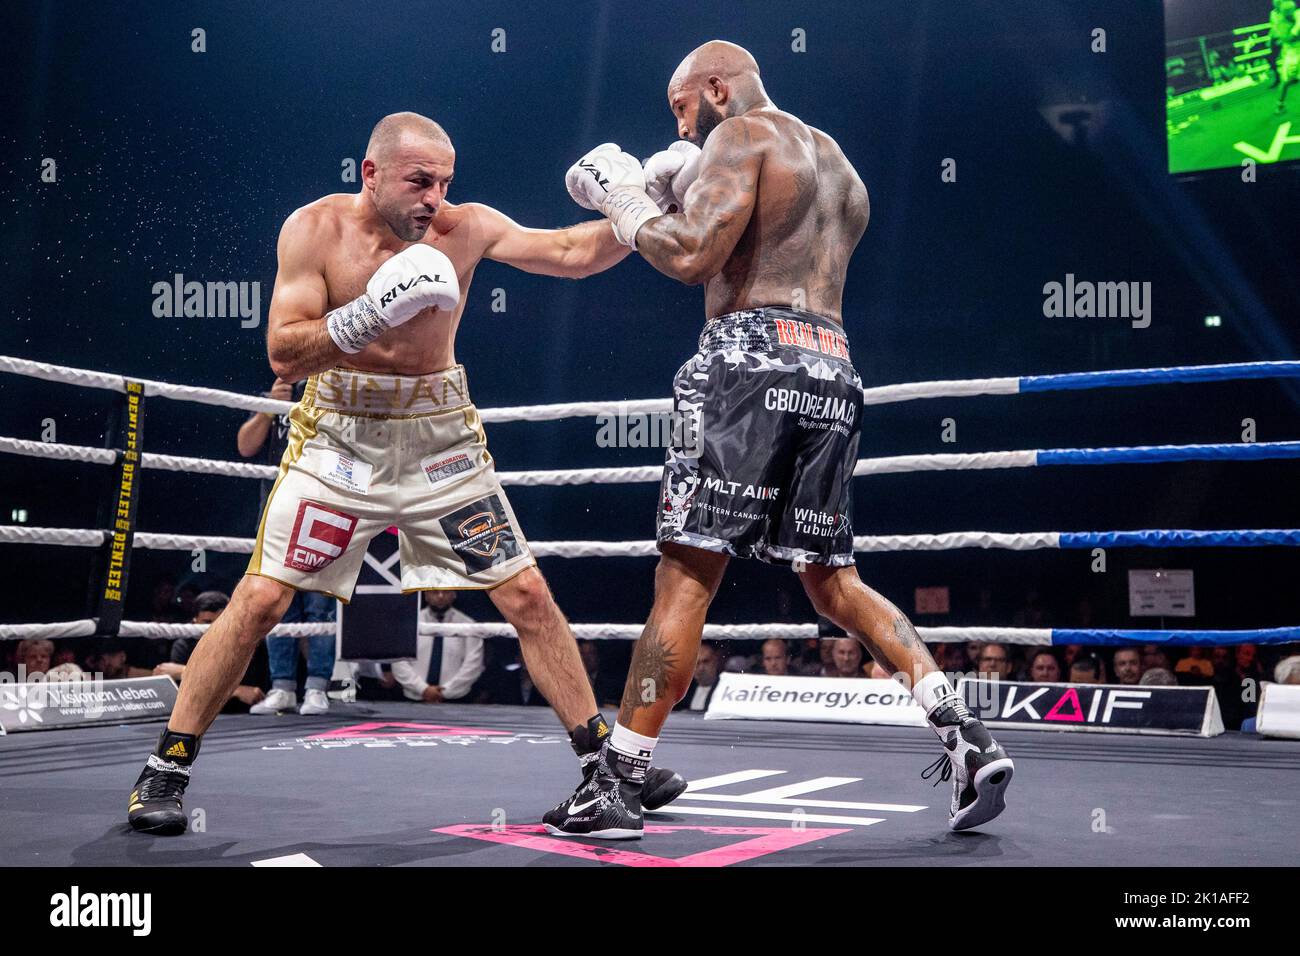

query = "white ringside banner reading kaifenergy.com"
[705, 674, 926, 727]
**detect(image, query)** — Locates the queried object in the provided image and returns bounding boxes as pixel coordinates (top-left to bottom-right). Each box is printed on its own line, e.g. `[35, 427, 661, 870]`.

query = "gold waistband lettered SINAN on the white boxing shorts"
[303, 365, 469, 419]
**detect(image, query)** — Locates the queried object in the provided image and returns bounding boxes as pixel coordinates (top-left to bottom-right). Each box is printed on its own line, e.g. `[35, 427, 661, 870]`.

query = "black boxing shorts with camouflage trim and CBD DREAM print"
[659, 307, 862, 570]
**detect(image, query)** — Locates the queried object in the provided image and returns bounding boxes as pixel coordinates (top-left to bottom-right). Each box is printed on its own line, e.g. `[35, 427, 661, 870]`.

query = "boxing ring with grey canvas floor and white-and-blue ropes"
[0, 356, 1300, 866]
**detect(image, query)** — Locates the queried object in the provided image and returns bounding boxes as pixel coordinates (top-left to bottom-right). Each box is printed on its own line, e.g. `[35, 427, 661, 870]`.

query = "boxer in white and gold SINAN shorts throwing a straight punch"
[127, 113, 685, 834]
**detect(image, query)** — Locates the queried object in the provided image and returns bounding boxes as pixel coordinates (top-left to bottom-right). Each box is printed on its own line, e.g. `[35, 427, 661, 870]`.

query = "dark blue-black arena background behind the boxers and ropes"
[0, 0, 1300, 627]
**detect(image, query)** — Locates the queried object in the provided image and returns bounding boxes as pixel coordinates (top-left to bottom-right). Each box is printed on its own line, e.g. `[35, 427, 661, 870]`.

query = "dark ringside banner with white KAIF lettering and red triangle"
[957, 678, 1223, 737]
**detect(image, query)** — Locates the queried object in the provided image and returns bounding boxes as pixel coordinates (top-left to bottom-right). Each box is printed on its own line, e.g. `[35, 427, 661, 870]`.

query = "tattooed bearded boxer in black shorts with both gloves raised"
[543, 40, 1014, 839]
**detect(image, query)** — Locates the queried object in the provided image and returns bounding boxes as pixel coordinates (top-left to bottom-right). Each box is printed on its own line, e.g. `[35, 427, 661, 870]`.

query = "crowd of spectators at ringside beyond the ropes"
[10, 579, 1300, 730]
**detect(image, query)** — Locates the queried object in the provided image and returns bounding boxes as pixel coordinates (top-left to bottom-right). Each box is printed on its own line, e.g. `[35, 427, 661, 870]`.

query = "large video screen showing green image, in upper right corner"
[1165, 0, 1300, 173]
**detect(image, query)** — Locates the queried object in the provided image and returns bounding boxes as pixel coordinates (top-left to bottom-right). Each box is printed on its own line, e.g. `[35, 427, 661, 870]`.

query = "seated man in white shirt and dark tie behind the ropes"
[391, 591, 484, 704]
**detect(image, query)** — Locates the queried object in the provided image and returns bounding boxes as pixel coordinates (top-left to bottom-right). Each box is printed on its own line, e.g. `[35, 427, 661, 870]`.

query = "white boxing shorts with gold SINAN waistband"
[248, 365, 536, 601]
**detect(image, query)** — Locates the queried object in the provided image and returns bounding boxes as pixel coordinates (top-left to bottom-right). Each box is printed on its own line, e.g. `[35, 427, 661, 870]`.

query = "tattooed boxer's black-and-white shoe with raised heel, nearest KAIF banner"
[920, 695, 1015, 830]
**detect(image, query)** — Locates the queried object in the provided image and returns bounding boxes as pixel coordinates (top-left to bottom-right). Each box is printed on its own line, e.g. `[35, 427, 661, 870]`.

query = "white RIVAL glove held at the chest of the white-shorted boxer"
[325, 242, 460, 355]
